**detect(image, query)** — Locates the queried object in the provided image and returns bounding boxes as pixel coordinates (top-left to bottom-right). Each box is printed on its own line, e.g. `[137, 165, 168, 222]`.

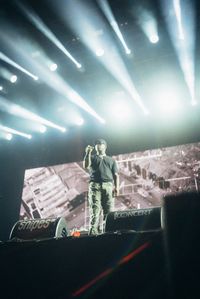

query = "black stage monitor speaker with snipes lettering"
[9, 217, 68, 240]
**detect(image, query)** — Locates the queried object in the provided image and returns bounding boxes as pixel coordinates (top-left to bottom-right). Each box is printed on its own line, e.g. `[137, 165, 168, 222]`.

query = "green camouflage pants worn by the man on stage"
[88, 182, 114, 235]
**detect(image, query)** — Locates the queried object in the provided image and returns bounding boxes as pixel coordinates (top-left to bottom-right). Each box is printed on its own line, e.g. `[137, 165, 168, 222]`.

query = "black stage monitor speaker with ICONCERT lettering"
[105, 207, 161, 232]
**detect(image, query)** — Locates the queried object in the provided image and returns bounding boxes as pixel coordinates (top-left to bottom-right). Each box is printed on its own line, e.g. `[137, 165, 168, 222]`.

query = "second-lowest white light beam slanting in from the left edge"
[0, 96, 66, 132]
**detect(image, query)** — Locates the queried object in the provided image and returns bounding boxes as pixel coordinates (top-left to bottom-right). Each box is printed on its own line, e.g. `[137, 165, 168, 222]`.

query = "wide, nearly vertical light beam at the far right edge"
[161, 0, 196, 105]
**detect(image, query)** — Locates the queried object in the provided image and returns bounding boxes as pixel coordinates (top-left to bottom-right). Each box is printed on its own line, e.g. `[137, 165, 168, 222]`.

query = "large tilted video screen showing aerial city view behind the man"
[20, 143, 200, 231]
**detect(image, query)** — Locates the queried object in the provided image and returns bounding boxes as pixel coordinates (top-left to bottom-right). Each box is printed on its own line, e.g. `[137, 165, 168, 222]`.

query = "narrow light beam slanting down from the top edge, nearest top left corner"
[17, 2, 82, 68]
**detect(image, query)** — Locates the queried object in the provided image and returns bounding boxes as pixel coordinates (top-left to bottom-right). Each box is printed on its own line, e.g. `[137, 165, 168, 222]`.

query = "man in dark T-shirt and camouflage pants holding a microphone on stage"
[83, 139, 119, 235]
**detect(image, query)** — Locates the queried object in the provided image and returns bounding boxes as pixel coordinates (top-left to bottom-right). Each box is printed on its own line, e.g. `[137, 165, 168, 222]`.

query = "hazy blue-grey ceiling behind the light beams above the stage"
[0, 0, 200, 166]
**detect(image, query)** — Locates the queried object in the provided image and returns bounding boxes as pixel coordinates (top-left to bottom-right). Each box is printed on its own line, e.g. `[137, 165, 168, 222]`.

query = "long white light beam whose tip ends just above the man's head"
[0, 29, 105, 124]
